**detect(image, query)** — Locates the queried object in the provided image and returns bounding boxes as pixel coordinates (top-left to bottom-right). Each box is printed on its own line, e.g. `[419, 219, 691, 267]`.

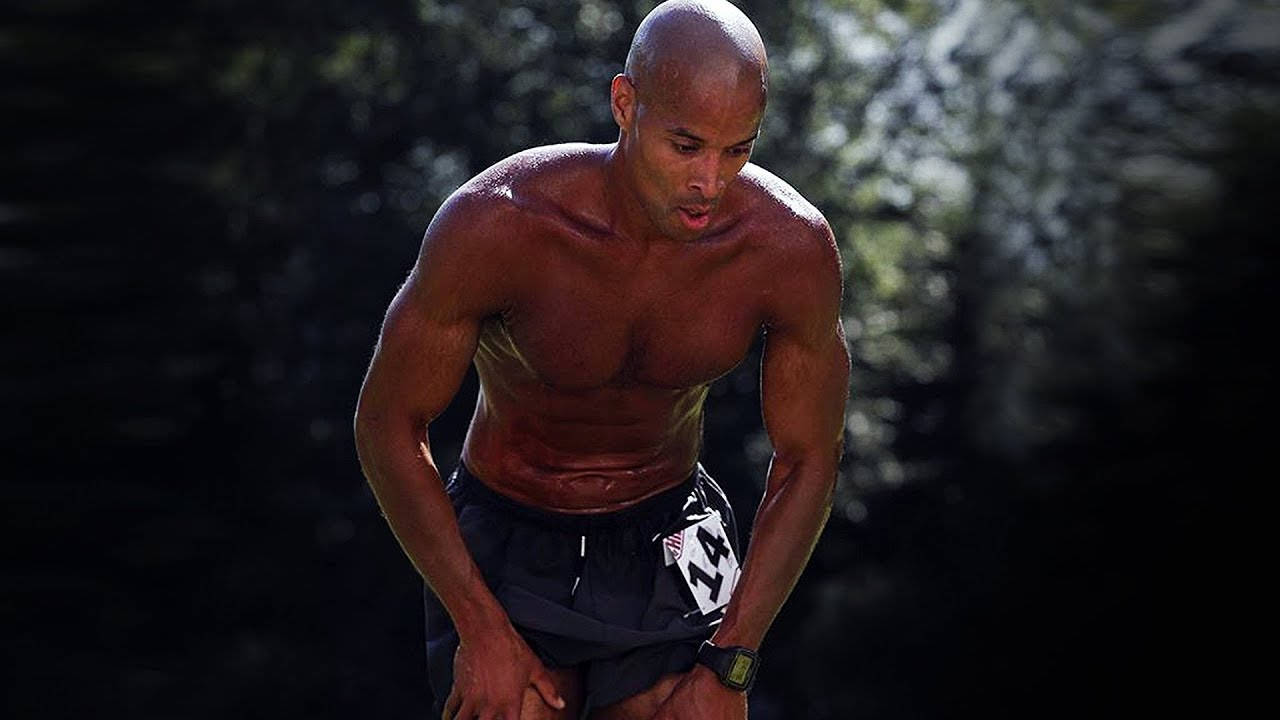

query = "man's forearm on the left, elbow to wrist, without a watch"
[356, 418, 506, 638]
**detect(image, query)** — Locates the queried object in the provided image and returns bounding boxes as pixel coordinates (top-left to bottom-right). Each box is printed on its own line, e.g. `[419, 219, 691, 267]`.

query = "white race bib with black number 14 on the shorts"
[662, 510, 741, 615]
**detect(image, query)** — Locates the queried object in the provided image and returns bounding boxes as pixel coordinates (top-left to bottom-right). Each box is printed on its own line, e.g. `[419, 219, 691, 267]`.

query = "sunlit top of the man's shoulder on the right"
[740, 163, 836, 261]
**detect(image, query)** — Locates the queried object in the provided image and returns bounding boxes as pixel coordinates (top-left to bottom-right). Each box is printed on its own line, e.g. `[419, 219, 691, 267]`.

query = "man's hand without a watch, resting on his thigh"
[442, 625, 564, 720]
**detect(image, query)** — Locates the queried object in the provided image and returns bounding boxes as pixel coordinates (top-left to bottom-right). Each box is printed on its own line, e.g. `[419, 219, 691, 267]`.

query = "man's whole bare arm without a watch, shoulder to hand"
[355, 188, 559, 717]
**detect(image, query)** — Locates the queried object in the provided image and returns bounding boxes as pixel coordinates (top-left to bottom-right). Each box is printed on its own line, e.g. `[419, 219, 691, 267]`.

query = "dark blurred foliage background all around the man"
[0, 0, 1280, 720]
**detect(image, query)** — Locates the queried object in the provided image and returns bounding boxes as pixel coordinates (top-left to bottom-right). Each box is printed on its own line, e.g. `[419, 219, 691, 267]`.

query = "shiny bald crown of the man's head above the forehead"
[626, 0, 769, 106]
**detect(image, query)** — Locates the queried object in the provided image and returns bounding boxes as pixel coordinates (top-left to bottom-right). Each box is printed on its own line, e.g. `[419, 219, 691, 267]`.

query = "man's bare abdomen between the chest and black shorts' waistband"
[462, 377, 707, 514]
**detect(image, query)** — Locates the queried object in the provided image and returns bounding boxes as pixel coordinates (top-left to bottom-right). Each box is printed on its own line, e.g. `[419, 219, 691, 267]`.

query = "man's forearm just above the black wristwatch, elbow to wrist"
[712, 457, 836, 648]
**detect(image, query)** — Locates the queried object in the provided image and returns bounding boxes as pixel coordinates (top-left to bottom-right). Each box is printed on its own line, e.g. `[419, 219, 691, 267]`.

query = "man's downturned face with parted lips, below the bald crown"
[623, 69, 764, 240]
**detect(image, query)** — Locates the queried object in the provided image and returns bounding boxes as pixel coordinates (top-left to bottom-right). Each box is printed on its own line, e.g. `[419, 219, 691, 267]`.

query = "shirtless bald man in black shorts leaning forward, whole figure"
[356, 0, 849, 720]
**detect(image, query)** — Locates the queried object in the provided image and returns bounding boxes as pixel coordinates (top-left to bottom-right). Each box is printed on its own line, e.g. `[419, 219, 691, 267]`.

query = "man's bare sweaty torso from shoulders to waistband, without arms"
[457, 146, 778, 512]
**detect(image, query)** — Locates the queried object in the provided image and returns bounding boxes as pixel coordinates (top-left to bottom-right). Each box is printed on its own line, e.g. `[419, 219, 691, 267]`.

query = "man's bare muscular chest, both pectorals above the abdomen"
[503, 238, 763, 389]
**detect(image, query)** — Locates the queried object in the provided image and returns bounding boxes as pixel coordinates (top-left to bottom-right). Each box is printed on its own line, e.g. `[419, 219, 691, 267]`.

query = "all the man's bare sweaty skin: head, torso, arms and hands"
[356, 0, 849, 720]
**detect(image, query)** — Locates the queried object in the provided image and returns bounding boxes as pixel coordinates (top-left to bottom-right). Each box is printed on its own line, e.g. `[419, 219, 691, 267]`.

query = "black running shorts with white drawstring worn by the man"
[425, 462, 741, 717]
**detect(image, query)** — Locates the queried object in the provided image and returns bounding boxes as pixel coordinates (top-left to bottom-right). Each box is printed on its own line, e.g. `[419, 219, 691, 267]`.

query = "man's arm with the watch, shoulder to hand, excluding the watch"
[654, 219, 850, 720]
